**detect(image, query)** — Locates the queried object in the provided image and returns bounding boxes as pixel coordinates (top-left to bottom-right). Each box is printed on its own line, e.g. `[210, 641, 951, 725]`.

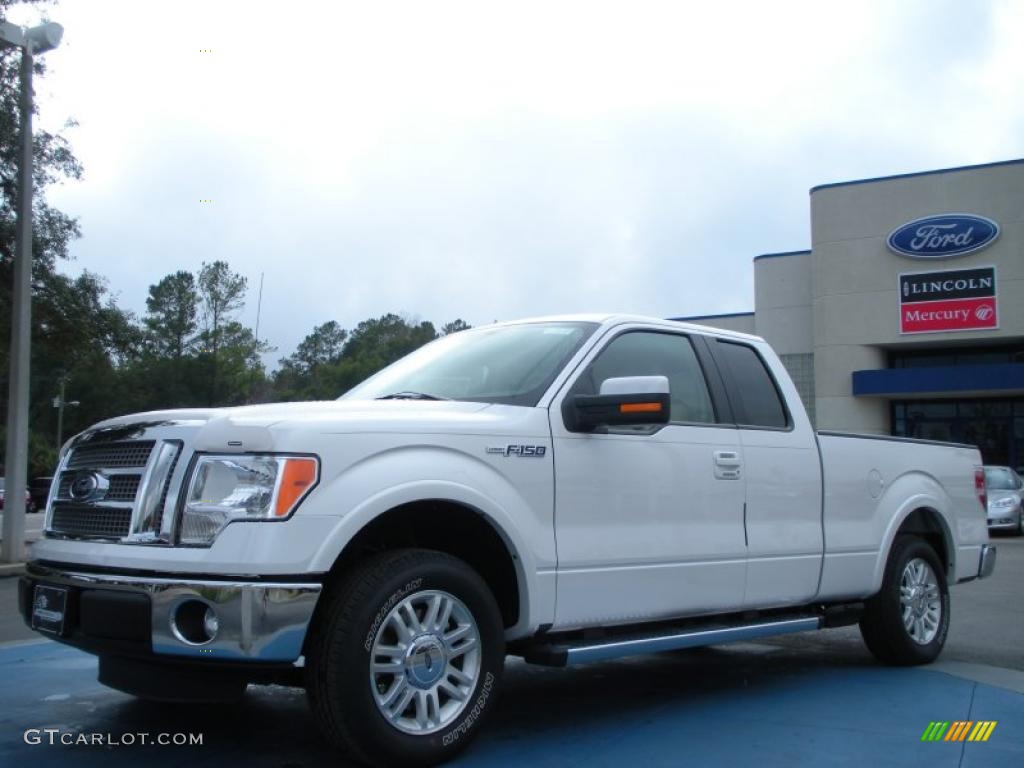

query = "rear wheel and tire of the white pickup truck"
[860, 537, 949, 667]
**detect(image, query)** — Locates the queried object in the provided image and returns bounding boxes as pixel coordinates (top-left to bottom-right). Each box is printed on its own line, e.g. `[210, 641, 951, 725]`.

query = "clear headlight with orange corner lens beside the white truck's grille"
[181, 454, 319, 545]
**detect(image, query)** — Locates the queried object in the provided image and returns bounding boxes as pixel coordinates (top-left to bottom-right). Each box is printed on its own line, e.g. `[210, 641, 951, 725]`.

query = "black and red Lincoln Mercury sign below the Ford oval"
[899, 266, 999, 334]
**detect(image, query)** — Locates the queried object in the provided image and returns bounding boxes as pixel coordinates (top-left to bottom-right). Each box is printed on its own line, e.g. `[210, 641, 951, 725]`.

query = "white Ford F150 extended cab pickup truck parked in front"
[20, 315, 995, 765]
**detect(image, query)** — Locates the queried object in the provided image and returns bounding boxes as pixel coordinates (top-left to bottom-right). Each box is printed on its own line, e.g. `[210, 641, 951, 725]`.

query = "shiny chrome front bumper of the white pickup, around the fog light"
[26, 564, 322, 662]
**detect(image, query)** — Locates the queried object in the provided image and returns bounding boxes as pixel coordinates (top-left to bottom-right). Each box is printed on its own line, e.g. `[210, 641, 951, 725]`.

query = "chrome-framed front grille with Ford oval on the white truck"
[46, 440, 182, 543]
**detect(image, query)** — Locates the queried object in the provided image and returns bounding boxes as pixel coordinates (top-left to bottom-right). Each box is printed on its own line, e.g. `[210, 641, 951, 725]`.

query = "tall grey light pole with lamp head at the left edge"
[0, 22, 63, 562]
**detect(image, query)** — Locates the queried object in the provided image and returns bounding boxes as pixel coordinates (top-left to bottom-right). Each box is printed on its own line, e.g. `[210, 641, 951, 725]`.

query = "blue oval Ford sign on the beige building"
[886, 213, 999, 259]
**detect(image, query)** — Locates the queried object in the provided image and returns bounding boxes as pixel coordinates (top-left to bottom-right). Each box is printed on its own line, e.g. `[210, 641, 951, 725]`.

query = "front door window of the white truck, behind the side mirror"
[572, 331, 715, 424]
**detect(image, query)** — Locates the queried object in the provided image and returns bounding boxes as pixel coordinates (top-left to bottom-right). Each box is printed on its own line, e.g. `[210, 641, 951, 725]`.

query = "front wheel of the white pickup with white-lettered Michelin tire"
[306, 549, 505, 765]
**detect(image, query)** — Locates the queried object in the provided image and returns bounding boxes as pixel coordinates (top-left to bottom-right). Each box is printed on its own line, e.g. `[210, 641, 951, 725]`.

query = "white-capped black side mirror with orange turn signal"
[562, 376, 670, 432]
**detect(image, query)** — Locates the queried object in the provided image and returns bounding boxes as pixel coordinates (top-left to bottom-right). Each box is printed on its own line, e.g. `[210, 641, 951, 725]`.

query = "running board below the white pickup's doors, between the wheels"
[522, 615, 823, 667]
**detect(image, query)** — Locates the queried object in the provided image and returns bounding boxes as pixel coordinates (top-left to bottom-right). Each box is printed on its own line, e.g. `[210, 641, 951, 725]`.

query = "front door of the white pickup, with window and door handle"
[550, 330, 746, 630]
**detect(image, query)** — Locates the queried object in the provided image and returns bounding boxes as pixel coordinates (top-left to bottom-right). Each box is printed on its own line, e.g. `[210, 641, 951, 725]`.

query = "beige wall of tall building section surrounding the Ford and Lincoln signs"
[806, 164, 1024, 433]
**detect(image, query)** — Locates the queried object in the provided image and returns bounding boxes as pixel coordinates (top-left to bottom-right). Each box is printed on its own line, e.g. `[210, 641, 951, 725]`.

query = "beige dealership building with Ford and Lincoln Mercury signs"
[679, 160, 1024, 467]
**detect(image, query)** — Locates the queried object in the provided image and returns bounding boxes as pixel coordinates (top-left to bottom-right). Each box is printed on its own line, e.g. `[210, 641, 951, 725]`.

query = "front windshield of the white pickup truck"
[339, 323, 597, 406]
